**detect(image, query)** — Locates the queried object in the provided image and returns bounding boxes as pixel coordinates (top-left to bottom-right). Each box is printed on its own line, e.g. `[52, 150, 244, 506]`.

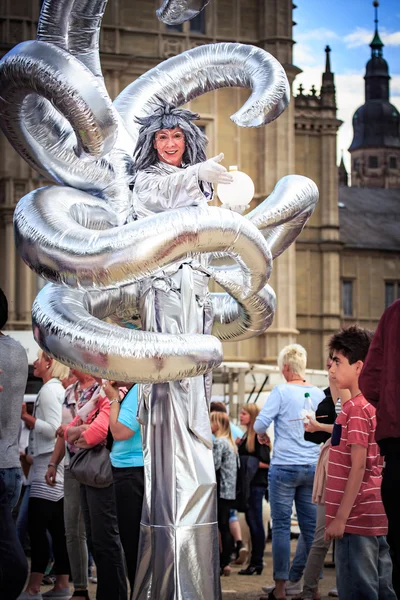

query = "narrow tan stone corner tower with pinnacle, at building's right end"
[295, 46, 342, 368]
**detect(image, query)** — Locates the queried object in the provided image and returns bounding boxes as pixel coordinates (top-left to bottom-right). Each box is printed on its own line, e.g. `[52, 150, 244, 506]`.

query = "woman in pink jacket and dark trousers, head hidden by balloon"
[65, 381, 128, 600]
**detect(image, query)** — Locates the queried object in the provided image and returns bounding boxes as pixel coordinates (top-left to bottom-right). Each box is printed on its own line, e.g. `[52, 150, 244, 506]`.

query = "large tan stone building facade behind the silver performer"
[0, 0, 400, 368]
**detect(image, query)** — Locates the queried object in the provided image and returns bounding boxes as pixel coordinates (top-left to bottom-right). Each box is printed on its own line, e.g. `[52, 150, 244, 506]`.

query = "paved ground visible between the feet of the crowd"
[42, 541, 336, 600]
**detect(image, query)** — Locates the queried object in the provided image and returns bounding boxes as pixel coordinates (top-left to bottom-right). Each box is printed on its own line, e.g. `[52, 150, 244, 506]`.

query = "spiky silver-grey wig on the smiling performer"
[133, 100, 208, 175]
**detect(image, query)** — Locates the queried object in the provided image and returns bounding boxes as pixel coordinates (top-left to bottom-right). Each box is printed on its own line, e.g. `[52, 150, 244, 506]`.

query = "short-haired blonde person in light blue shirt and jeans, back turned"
[254, 344, 325, 600]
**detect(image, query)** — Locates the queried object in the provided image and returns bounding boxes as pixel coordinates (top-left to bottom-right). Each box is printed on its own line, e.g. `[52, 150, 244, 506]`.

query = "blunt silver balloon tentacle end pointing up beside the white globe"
[246, 175, 319, 258]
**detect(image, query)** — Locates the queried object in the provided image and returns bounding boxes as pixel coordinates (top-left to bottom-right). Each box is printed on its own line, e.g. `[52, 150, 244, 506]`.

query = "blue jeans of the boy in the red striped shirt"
[335, 533, 396, 600]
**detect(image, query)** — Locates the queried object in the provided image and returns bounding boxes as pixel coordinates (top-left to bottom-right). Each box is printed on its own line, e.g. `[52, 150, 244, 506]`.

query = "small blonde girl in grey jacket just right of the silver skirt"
[210, 412, 238, 575]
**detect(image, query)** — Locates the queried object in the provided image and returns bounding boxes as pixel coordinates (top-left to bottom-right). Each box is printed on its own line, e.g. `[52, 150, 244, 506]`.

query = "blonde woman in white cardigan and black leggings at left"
[19, 350, 70, 600]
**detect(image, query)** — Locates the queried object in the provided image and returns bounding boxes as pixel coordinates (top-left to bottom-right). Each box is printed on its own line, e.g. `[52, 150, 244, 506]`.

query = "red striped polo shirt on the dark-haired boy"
[325, 394, 387, 536]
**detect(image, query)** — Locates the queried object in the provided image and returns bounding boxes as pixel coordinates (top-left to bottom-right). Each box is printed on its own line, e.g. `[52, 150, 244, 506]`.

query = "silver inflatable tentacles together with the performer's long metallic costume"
[0, 0, 318, 600]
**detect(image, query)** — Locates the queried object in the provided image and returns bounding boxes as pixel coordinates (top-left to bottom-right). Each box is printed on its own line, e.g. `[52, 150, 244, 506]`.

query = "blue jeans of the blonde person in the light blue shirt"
[268, 465, 316, 580]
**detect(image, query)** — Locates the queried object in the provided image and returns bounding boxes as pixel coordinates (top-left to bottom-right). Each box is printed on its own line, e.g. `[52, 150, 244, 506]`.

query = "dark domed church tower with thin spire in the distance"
[349, 1, 400, 189]
